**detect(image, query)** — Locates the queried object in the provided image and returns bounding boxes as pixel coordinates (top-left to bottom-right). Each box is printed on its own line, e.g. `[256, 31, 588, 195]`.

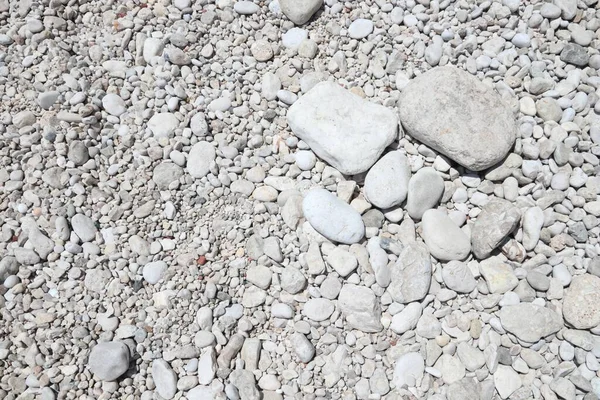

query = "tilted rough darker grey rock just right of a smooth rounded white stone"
[471, 198, 521, 259]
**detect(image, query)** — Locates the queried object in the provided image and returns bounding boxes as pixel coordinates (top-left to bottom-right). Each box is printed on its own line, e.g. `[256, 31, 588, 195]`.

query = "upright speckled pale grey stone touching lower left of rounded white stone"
[388, 242, 431, 303]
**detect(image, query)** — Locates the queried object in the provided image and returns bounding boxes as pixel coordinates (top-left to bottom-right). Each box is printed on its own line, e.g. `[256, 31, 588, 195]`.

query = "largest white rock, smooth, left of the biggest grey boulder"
[287, 81, 398, 175]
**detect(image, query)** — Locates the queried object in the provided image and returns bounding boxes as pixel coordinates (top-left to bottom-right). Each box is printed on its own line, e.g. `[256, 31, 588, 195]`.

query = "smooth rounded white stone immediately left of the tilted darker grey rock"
[421, 210, 471, 261]
